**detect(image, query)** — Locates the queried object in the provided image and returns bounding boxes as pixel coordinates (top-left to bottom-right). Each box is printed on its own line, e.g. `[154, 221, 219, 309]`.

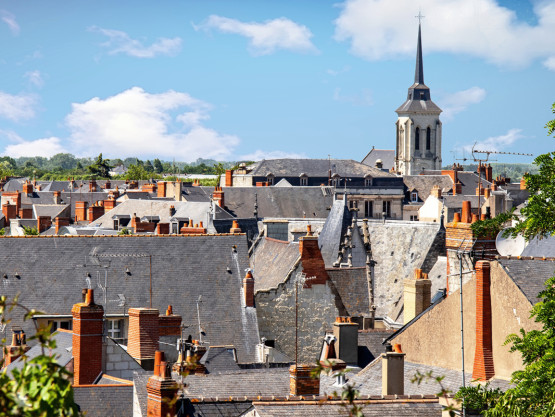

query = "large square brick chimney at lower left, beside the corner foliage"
[71, 290, 104, 385]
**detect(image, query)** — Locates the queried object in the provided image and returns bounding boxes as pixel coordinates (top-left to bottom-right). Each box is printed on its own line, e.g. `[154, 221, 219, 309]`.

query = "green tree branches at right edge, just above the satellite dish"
[511, 103, 555, 240]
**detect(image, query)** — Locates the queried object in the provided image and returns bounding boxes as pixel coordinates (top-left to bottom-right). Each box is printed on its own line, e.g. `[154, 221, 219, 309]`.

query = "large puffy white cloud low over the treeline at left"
[66, 87, 239, 161]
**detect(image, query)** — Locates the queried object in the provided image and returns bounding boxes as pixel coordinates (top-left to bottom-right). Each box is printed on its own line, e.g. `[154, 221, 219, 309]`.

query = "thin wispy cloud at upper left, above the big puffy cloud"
[89, 26, 181, 58]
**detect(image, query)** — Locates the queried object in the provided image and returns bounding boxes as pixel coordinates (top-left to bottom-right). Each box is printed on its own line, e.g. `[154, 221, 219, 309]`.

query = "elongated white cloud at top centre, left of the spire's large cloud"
[197, 15, 317, 55]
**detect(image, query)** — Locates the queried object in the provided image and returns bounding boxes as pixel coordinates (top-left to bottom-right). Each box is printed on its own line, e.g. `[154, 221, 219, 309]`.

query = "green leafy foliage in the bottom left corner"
[0, 296, 81, 417]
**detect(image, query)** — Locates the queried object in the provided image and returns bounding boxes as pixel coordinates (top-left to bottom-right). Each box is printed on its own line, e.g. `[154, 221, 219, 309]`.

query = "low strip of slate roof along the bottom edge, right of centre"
[254, 400, 442, 417]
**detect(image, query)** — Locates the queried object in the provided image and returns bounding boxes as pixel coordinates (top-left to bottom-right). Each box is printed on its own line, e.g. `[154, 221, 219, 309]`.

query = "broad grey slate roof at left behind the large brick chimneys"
[0, 235, 260, 362]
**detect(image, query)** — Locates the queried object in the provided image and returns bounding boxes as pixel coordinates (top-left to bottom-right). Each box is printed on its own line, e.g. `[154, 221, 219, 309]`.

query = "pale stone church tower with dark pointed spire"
[395, 24, 441, 175]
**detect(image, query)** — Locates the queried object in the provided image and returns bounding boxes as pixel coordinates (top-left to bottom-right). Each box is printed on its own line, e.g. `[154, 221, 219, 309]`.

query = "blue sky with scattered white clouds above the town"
[0, 0, 555, 165]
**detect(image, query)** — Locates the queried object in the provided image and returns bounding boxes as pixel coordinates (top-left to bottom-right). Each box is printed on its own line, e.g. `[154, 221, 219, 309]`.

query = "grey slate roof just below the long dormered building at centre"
[224, 187, 333, 218]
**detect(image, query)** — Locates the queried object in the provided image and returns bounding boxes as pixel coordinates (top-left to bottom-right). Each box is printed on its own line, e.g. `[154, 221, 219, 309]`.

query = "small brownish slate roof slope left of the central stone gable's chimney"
[251, 237, 301, 293]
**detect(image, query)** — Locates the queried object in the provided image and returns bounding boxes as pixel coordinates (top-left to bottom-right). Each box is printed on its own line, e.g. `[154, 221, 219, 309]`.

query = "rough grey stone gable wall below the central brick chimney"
[255, 264, 340, 363]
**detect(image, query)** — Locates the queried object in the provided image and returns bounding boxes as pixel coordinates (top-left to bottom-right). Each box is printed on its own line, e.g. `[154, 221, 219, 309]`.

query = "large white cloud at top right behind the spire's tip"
[335, 0, 555, 69]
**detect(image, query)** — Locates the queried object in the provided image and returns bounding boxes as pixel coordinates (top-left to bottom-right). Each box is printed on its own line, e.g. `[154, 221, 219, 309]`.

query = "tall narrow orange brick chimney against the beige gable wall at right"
[472, 261, 495, 381]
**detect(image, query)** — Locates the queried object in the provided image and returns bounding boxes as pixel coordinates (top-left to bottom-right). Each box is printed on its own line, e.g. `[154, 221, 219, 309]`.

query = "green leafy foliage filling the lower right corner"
[485, 277, 555, 417]
